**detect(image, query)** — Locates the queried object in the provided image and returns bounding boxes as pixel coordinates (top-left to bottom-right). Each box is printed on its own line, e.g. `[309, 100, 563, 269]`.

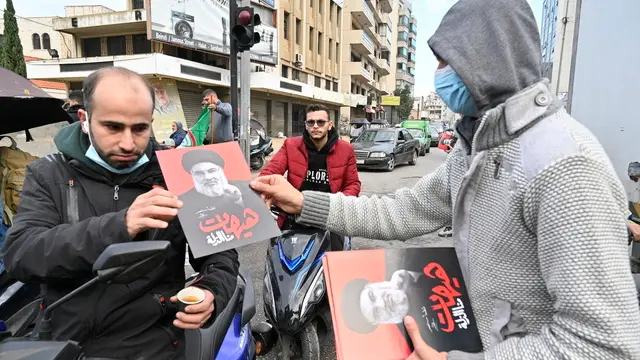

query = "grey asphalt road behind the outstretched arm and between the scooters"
[239, 148, 451, 360]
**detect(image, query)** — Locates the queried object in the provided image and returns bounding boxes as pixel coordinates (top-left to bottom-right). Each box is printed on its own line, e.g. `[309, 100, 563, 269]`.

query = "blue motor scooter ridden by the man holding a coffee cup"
[0, 241, 272, 360]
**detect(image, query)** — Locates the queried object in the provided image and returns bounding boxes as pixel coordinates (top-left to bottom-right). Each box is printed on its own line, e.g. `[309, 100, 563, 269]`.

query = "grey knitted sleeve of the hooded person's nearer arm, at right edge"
[449, 155, 640, 360]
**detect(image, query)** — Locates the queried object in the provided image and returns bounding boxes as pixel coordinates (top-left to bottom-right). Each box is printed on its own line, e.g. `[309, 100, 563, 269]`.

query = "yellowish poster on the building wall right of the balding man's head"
[149, 79, 187, 143]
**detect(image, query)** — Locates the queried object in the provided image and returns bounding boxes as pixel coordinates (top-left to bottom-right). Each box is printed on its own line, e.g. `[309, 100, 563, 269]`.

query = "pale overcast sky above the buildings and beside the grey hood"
[5, 0, 543, 96]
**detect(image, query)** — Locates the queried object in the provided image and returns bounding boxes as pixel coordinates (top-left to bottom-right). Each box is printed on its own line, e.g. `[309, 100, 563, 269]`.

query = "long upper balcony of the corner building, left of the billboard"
[53, 10, 147, 36]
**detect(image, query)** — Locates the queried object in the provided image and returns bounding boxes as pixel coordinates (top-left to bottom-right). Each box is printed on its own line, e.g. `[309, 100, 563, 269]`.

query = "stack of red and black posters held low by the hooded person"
[323, 248, 482, 360]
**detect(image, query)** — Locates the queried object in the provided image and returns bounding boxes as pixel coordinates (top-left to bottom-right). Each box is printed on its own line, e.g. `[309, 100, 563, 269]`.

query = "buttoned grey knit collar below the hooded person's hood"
[473, 79, 563, 151]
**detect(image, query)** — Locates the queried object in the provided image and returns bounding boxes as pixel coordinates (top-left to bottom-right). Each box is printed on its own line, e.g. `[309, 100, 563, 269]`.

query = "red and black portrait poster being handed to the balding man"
[158, 142, 280, 258]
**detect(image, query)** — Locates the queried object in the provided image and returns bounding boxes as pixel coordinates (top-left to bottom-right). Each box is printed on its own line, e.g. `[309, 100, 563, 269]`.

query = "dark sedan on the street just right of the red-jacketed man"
[353, 127, 420, 171]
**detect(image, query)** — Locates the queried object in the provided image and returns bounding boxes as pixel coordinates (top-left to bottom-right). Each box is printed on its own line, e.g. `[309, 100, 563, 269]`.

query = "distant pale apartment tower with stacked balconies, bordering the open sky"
[395, 0, 418, 94]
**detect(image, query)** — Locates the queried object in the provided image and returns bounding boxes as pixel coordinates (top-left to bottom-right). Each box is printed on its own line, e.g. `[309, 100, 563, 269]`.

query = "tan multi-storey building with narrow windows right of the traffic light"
[276, 0, 349, 135]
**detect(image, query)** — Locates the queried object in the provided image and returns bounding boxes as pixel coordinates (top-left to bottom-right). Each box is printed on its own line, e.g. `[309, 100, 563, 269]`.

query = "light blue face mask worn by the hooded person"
[434, 65, 478, 116]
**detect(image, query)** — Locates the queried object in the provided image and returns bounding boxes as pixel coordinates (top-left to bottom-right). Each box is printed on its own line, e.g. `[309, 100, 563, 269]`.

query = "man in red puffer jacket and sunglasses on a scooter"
[260, 105, 360, 248]
